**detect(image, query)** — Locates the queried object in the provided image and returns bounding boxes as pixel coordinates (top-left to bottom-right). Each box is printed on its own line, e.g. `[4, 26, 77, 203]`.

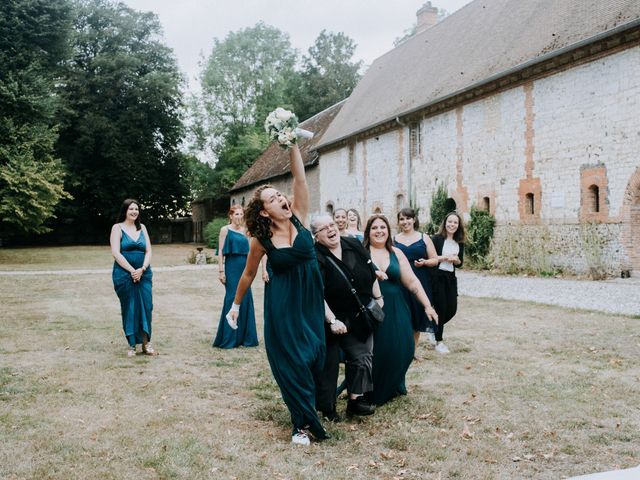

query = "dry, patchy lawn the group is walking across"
[0, 245, 640, 479]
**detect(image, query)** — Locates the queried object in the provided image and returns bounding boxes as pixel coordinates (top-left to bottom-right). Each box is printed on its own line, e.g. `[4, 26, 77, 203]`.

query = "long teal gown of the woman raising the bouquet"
[261, 216, 327, 439]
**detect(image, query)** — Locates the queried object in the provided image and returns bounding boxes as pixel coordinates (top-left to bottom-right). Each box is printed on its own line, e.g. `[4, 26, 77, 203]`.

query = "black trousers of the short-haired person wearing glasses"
[316, 325, 373, 412]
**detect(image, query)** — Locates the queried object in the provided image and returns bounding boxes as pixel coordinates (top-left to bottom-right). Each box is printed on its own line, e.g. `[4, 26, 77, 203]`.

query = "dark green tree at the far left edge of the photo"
[0, 0, 71, 235]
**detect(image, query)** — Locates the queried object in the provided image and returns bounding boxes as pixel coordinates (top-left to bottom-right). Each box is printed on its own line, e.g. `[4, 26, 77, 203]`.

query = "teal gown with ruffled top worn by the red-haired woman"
[213, 228, 258, 348]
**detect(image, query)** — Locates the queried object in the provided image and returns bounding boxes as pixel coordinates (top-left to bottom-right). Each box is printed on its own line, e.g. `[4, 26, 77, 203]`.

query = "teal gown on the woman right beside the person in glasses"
[367, 252, 414, 405]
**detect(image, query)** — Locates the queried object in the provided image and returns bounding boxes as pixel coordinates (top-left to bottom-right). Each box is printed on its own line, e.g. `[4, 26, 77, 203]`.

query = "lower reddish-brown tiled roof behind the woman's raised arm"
[230, 100, 344, 192]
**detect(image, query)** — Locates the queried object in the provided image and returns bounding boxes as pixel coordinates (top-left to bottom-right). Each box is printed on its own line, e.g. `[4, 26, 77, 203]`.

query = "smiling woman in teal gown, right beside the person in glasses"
[364, 215, 438, 405]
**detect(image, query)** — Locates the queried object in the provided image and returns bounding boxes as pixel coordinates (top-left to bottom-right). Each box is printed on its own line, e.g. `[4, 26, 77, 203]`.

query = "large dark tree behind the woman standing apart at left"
[58, 0, 188, 229]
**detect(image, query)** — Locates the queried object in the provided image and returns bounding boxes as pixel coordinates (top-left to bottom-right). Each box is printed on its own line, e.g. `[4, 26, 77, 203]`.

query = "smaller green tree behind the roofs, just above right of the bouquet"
[293, 30, 363, 120]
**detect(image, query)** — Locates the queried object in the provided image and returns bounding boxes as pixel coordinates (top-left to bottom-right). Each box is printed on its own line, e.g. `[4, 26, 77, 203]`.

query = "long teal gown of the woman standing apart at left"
[111, 229, 153, 346]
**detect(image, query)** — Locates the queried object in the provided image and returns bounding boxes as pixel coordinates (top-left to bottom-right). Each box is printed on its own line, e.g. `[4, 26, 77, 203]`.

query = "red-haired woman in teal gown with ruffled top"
[213, 205, 258, 348]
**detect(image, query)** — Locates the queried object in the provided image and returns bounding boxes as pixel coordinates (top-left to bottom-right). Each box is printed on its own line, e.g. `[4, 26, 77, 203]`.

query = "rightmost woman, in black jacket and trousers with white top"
[431, 212, 465, 353]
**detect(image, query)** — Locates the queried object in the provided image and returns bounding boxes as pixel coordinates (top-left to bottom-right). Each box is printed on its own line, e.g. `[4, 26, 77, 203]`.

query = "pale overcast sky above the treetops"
[122, 0, 470, 90]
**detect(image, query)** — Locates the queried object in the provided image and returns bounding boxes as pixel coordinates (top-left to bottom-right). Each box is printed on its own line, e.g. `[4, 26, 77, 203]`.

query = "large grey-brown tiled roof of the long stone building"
[318, 0, 640, 147]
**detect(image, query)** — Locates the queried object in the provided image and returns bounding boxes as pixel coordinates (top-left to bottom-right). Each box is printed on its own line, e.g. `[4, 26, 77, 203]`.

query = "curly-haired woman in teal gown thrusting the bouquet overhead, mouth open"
[227, 145, 328, 445]
